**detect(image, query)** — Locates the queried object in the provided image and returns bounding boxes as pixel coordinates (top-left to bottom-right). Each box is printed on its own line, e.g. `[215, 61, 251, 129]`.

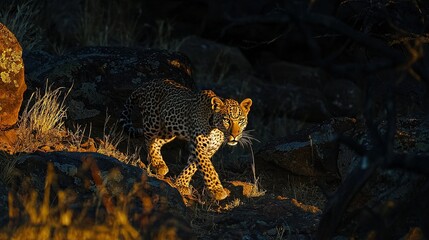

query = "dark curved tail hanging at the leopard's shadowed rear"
[119, 89, 143, 138]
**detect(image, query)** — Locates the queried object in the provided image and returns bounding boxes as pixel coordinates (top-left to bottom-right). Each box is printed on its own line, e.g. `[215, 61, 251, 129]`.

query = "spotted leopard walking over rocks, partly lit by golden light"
[119, 79, 252, 200]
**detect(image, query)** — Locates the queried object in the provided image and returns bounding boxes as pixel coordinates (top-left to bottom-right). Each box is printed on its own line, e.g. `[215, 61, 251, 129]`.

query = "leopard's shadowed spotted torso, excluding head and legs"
[120, 79, 198, 139]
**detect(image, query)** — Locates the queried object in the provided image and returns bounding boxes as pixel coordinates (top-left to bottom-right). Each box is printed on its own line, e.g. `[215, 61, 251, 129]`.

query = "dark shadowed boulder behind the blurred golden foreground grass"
[11, 152, 185, 214]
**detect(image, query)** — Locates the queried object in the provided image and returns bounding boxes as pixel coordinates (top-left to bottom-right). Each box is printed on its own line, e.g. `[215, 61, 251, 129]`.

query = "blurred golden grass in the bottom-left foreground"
[0, 161, 153, 240]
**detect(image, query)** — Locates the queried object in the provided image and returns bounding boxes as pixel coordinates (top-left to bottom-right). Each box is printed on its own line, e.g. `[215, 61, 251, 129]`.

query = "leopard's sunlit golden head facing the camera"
[211, 97, 252, 146]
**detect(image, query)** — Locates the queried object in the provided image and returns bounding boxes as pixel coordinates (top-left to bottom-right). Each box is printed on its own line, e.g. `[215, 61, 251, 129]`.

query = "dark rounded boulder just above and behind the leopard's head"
[179, 36, 252, 89]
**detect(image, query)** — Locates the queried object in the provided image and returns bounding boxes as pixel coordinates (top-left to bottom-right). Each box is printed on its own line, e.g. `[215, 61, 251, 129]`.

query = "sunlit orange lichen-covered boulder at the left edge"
[0, 23, 27, 130]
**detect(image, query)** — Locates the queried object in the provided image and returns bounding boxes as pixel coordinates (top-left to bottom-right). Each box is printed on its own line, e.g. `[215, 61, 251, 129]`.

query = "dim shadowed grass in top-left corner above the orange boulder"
[0, 1, 43, 51]
